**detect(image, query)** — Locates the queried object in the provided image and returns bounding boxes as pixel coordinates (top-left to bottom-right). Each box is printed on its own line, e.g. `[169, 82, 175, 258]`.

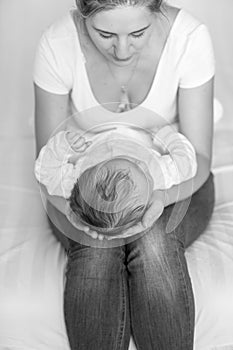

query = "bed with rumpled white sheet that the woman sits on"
[0, 2, 233, 350]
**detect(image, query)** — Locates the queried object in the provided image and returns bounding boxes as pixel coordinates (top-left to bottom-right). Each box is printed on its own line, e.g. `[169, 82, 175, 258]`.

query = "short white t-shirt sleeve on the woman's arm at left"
[33, 32, 71, 94]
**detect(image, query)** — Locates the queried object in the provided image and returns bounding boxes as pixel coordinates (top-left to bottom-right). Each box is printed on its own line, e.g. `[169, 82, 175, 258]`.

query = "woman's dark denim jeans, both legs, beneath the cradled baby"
[64, 174, 214, 350]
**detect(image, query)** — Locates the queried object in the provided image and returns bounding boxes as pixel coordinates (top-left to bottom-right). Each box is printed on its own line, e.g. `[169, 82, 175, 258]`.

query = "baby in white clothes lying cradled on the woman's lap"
[35, 125, 197, 235]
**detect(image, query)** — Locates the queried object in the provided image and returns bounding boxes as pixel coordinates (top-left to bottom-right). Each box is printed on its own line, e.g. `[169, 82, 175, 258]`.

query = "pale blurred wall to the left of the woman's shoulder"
[0, 0, 74, 134]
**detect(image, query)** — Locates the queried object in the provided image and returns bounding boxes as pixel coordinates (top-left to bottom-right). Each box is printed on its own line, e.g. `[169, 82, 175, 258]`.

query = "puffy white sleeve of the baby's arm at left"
[35, 131, 80, 198]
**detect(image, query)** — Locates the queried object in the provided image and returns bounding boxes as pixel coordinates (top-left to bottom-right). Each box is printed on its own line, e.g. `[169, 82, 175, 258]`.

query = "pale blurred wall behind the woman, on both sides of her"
[0, 0, 233, 136]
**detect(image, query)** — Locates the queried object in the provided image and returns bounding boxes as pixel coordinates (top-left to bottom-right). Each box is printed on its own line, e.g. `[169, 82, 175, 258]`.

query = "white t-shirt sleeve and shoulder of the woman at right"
[165, 8, 215, 88]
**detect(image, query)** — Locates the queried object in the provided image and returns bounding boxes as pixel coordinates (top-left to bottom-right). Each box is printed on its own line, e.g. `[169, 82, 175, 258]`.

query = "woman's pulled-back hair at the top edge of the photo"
[76, 0, 163, 18]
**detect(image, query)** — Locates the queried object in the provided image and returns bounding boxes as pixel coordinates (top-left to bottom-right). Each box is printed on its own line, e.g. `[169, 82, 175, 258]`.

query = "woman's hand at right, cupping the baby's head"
[104, 190, 165, 240]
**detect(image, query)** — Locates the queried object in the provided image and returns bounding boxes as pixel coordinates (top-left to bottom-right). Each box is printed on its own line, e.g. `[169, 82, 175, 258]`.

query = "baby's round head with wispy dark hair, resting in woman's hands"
[69, 164, 146, 229]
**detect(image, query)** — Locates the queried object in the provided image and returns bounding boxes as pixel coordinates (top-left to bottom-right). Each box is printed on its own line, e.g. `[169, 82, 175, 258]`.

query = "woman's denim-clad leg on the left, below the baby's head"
[64, 240, 130, 350]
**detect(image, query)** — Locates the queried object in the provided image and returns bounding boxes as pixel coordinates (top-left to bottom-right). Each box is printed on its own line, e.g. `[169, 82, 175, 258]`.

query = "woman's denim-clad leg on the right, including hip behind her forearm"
[123, 174, 214, 350]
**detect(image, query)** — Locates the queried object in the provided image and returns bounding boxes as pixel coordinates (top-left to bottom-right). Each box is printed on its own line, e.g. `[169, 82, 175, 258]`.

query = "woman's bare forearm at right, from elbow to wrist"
[165, 154, 210, 207]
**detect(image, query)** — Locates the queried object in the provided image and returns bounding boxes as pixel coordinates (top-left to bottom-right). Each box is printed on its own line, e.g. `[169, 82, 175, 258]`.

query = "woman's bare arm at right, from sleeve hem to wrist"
[165, 78, 214, 206]
